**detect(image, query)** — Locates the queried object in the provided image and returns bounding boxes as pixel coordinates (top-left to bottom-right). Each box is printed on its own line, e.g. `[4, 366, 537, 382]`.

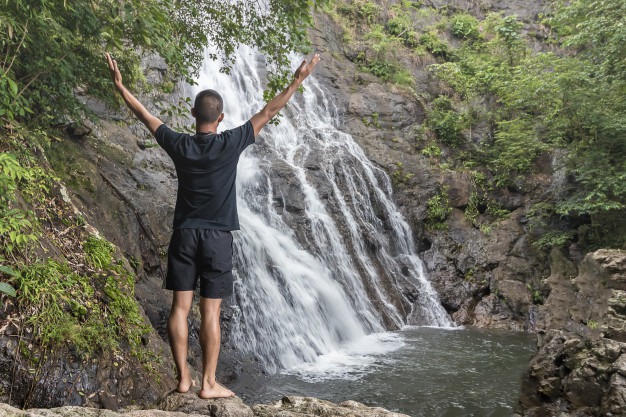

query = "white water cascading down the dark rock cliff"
[189, 47, 453, 371]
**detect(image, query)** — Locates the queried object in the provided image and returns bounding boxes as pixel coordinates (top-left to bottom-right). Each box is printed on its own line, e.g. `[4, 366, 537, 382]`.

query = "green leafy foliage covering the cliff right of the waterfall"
[336, 0, 626, 247]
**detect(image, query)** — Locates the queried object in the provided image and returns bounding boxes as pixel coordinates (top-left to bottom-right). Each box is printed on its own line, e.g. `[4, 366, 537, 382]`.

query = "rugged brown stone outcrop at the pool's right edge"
[519, 249, 626, 417]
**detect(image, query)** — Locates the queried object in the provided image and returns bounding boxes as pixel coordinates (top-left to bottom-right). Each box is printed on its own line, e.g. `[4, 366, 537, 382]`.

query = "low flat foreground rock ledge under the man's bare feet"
[0, 393, 408, 417]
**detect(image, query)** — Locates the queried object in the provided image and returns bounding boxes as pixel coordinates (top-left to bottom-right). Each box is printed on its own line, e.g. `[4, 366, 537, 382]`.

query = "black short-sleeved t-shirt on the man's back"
[154, 121, 254, 230]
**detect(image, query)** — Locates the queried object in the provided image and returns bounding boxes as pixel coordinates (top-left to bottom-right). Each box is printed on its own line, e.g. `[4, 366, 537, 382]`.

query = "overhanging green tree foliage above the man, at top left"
[0, 0, 325, 124]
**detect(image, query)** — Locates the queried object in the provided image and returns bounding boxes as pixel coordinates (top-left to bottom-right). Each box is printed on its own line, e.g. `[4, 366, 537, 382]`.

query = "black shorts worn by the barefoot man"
[165, 229, 233, 298]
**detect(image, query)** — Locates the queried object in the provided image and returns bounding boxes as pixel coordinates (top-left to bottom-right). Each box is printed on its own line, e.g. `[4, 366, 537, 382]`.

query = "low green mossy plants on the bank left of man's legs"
[16, 245, 150, 358]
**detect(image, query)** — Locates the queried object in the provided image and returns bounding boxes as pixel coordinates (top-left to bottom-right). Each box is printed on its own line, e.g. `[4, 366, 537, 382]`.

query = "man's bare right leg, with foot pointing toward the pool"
[198, 297, 235, 398]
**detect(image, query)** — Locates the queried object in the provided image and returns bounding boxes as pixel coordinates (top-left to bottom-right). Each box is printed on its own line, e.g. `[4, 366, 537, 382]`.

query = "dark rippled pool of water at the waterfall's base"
[232, 327, 535, 417]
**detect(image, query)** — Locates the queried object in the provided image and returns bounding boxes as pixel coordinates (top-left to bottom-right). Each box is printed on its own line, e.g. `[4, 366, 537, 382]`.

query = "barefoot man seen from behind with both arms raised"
[106, 53, 320, 398]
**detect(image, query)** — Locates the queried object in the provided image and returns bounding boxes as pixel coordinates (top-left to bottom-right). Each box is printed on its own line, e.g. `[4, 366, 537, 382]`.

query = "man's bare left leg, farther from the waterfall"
[167, 291, 193, 392]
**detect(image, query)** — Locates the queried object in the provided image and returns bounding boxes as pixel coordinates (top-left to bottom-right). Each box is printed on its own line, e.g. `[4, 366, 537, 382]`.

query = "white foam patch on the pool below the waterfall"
[282, 332, 406, 383]
